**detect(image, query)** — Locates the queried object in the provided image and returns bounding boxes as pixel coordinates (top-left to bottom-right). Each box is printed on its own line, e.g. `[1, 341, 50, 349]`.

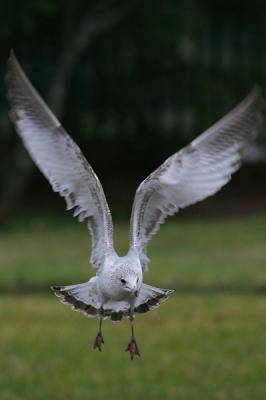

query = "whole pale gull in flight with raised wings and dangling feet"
[6, 51, 266, 359]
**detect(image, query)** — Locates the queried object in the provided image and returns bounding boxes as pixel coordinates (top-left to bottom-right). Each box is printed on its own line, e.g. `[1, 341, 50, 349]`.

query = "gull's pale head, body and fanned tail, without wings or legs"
[53, 250, 172, 321]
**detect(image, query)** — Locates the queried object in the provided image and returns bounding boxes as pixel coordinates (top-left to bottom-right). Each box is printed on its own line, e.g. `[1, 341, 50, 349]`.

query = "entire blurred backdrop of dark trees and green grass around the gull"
[0, 0, 266, 400]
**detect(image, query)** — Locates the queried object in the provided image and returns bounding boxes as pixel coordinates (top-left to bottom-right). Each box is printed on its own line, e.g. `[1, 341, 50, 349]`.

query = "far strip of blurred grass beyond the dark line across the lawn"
[0, 216, 266, 290]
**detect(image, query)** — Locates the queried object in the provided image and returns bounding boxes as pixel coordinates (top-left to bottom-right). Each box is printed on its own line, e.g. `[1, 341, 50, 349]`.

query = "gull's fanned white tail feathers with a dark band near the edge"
[51, 277, 174, 321]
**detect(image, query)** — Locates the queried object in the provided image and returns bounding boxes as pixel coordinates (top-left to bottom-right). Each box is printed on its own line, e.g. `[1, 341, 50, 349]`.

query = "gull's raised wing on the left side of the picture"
[6, 52, 114, 267]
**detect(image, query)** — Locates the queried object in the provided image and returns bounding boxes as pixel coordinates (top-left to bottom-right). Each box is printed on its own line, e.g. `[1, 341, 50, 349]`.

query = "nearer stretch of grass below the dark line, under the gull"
[0, 295, 266, 400]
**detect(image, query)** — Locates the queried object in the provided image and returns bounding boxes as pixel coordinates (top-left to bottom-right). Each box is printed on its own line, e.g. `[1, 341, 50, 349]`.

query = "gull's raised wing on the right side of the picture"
[130, 87, 266, 270]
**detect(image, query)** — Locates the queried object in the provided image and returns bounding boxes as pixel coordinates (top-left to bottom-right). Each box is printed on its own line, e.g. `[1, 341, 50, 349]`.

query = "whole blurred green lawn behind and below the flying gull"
[0, 216, 266, 400]
